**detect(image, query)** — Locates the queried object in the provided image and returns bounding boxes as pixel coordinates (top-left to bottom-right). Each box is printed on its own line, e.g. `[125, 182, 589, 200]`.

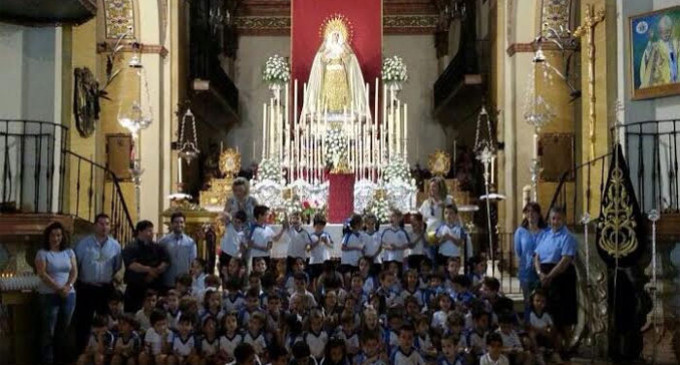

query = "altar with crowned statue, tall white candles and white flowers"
[251, 14, 417, 223]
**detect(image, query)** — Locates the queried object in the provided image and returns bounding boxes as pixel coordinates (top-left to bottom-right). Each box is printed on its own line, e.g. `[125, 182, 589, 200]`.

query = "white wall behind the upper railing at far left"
[0, 24, 61, 211]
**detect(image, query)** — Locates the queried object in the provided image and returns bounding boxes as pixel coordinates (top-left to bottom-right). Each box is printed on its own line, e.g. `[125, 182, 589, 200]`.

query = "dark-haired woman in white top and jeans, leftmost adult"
[35, 222, 78, 365]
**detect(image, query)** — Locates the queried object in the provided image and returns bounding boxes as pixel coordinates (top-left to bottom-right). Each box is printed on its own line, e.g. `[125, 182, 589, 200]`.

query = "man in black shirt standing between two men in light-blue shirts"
[123, 220, 170, 313]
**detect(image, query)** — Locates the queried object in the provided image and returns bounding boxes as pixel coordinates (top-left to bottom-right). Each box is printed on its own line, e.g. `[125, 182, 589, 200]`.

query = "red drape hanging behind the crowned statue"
[291, 0, 382, 115]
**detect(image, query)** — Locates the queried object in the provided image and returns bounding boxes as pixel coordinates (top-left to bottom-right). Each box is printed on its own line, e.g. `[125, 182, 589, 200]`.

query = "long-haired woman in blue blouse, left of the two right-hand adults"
[514, 202, 546, 315]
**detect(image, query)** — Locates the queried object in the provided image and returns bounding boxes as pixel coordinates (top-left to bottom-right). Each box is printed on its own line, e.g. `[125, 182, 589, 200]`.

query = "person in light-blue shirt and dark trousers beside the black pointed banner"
[534, 207, 577, 356]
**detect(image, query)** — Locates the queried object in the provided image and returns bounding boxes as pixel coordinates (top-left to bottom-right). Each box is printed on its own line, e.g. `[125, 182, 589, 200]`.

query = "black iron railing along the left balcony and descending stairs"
[0, 120, 133, 243]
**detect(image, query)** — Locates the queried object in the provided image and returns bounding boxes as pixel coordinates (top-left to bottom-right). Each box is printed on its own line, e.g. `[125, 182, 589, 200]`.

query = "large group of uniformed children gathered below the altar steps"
[79, 206, 554, 365]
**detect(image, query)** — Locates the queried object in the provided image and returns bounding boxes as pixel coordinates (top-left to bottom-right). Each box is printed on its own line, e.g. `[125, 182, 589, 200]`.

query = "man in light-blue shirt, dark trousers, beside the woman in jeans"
[75, 213, 123, 353]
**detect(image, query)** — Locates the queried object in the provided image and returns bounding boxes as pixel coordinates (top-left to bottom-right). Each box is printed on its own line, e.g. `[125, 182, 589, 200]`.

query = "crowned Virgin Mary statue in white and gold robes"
[302, 16, 370, 117]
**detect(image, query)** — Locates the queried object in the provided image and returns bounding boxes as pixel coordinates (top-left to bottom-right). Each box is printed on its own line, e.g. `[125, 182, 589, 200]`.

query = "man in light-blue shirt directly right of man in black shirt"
[158, 212, 197, 289]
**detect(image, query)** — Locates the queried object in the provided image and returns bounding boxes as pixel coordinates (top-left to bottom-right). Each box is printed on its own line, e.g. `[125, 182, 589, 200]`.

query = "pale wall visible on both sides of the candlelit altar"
[234, 35, 445, 166]
